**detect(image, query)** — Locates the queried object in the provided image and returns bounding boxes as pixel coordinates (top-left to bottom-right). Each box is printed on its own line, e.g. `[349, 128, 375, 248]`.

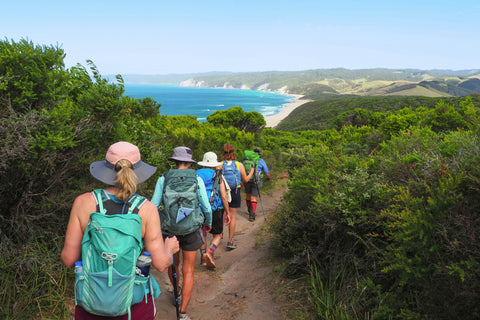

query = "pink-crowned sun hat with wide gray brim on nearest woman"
[90, 141, 157, 186]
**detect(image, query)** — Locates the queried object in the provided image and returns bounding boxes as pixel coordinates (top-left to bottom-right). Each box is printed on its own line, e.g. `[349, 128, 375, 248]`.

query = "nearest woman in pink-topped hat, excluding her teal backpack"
[61, 141, 179, 320]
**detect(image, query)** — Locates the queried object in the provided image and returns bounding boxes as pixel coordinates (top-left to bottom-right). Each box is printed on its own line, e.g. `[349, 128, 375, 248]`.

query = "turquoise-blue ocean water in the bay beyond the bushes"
[125, 84, 294, 121]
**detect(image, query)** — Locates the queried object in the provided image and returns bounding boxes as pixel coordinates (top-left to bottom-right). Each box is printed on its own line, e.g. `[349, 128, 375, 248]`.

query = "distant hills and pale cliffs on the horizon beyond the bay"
[122, 68, 480, 97]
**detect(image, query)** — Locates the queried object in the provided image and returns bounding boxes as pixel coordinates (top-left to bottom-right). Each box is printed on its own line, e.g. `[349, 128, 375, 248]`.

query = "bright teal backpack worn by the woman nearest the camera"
[75, 190, 153, 319]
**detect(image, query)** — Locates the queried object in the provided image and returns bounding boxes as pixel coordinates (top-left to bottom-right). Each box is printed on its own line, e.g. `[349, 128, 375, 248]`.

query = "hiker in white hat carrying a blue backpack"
[197, 152, 230, 269]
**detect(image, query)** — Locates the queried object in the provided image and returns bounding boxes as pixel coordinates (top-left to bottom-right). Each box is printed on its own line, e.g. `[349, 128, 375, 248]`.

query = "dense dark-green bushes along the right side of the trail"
[267, 97, 480, 319]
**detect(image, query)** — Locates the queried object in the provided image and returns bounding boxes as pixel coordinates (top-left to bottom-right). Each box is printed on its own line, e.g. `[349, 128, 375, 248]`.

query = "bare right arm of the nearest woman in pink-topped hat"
[142, 201, 179, 271]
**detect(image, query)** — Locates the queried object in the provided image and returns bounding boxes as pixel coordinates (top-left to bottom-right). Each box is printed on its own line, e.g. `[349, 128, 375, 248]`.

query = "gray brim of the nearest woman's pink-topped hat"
[90, 160, 157, 186]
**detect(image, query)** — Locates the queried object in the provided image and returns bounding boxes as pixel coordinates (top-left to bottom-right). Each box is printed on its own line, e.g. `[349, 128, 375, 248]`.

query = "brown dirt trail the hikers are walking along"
[153, 190, 283, 320]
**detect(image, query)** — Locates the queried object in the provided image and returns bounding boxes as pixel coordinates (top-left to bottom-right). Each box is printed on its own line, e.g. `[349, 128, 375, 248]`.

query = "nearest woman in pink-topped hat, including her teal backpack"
[61, 141, 179, 320]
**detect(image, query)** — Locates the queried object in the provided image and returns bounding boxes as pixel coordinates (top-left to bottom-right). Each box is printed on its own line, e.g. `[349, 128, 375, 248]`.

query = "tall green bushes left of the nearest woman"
[0, 40, 175, 319]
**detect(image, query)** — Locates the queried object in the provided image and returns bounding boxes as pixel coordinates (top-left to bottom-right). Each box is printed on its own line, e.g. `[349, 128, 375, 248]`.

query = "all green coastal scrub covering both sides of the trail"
[0, 40, 480, 320]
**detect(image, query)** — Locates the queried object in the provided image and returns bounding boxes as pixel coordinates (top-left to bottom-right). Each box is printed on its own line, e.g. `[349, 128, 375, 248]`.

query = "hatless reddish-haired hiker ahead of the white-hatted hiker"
[222, 143, 254, 250]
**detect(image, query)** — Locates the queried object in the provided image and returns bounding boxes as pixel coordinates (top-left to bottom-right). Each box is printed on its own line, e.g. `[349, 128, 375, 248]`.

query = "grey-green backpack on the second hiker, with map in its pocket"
[160, 169, 204, 236]
